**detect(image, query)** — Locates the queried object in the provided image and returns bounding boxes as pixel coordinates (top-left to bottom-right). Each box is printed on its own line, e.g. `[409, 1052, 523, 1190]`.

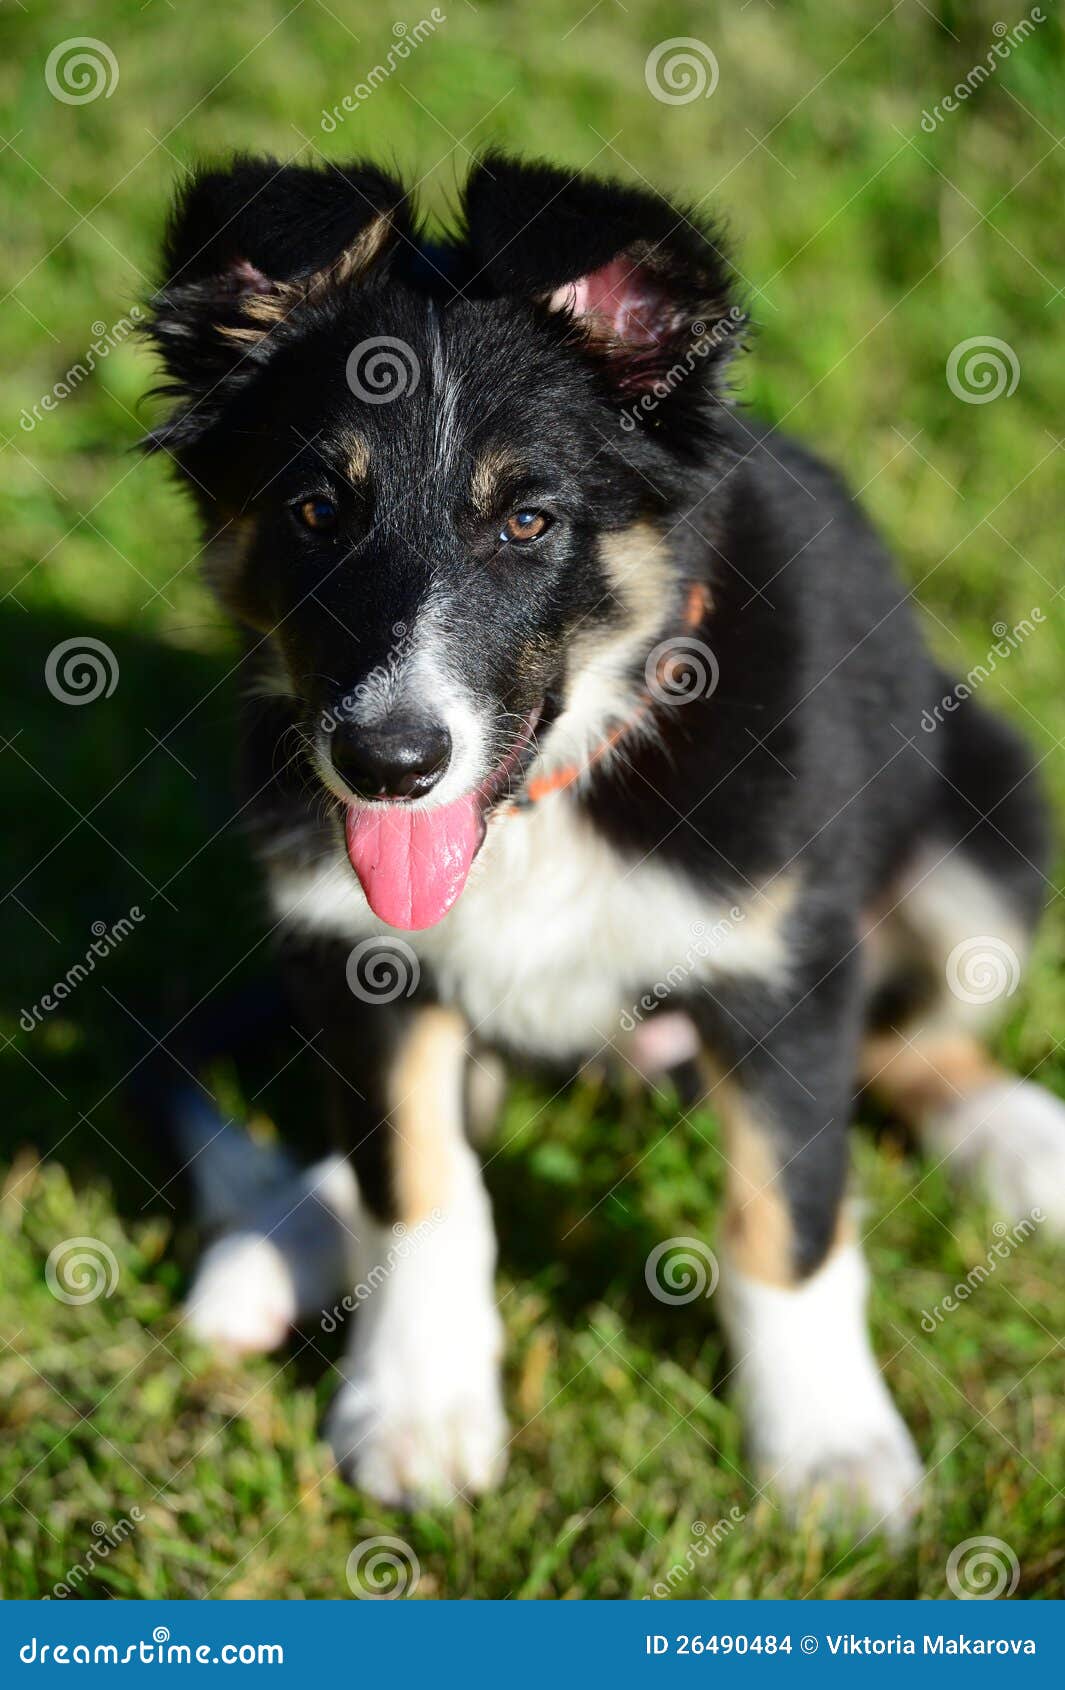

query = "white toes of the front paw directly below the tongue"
[326, 1357, 507, 1507]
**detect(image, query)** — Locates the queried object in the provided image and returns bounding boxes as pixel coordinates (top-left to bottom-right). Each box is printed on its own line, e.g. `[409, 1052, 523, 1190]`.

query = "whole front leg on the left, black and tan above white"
[292, 953, 505, 1504]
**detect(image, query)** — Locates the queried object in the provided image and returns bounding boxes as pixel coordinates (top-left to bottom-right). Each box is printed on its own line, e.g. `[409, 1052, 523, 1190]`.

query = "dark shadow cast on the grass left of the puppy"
[0, 600, 265, 1217]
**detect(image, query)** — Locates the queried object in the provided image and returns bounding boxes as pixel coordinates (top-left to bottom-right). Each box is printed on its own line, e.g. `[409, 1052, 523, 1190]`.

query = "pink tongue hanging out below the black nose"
[345, 794, 485, 928]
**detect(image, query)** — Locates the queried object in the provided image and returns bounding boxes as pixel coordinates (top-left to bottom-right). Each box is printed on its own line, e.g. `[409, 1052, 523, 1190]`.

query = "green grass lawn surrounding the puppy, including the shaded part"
[0, 0, 1065, 1597]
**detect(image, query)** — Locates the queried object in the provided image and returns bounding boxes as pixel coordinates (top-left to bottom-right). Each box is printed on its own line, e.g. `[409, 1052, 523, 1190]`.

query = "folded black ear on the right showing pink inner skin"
[465, 154, 746, 408]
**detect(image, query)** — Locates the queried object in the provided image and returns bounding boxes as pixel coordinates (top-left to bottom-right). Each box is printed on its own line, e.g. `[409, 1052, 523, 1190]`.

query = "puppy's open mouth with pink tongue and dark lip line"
[345, 700, 548, 931]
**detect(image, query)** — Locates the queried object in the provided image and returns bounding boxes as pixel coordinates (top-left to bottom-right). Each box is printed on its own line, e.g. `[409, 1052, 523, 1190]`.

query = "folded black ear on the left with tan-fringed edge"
[147, 157, 411, 446]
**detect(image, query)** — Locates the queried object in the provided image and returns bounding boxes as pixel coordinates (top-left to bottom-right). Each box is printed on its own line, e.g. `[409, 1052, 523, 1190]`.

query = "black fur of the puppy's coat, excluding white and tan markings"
[152, 155, 1046, 1273]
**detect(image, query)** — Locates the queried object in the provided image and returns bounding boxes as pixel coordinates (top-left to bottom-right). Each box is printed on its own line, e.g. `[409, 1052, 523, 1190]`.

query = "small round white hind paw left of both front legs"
[184, 1232, 296, 1355]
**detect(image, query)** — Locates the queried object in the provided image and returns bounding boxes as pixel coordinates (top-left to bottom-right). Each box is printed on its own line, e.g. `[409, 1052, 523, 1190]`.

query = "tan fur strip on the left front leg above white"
[389, 1007, 467, 1227]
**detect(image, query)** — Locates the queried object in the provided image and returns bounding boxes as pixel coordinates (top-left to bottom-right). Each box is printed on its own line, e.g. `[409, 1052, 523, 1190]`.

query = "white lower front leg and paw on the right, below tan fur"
[722, 1246, 921, 1536]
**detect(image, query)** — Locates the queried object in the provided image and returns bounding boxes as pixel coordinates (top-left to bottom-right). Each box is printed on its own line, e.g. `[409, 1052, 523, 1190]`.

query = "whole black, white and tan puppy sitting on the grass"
[152, 154, 1065, 1526]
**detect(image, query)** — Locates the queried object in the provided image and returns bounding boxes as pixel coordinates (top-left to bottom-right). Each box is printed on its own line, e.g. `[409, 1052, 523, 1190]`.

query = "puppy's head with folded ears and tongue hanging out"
[152, 155, 742, 928]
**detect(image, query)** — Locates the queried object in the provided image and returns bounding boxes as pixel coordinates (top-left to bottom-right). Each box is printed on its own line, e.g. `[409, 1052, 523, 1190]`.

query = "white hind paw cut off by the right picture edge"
[928, 1080, 1065, 1235]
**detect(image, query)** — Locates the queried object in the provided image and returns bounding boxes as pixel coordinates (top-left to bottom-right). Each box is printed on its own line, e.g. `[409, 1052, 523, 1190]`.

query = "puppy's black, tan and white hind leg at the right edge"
[862, 706, 1065, 1232]
